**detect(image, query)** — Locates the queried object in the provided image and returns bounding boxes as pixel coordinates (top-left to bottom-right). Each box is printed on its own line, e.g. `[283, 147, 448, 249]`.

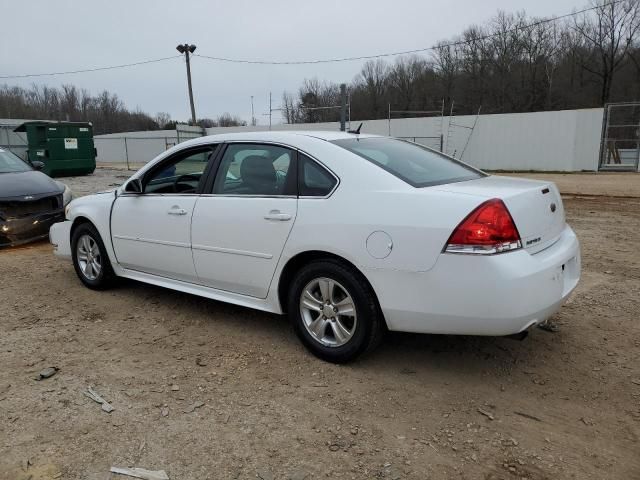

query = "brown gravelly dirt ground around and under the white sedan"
[0, 170, 640, 480]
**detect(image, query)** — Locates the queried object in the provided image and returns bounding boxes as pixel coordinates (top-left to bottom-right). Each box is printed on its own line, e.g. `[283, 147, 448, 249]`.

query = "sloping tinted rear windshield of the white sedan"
[332, 137, 485, 187]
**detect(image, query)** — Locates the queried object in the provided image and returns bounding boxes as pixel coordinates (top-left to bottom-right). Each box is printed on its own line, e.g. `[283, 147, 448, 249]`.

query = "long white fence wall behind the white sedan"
[95, 108, 603, 171]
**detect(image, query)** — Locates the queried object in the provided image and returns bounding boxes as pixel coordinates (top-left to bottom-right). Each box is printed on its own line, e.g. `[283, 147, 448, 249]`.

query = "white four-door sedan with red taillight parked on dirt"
[50, 132, 580, 362]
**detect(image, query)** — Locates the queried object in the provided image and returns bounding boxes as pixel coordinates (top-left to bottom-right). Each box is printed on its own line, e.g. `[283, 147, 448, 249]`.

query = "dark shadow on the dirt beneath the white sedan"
[116, 274, 562, 374]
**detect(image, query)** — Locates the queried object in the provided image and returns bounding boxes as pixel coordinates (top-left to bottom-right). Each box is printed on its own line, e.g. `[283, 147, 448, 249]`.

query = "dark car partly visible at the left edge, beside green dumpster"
[0, 149, 72, 248]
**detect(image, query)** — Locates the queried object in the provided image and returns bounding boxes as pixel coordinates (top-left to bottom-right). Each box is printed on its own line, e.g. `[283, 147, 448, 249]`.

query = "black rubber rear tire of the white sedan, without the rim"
[287, 259, 385, 363]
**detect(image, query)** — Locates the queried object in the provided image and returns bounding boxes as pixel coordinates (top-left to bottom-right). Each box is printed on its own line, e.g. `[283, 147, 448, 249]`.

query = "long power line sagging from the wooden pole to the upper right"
[194, 0, 622, 65]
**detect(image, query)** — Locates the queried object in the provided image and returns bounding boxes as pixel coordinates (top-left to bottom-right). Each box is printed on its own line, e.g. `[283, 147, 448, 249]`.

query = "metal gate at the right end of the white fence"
[599, 102, 640, 171]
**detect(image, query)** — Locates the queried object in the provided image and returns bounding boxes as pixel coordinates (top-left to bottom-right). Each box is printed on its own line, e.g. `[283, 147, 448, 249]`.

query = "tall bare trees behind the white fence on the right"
[282, 0, 640, 123]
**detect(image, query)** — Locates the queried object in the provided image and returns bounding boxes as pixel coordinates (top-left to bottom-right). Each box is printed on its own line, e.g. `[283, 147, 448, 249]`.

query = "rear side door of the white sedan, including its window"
[191, 143, 297, 298]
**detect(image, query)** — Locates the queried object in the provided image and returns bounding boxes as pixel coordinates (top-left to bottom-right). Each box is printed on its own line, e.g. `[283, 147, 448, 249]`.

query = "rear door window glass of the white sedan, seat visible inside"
[213, 143, 295, 196]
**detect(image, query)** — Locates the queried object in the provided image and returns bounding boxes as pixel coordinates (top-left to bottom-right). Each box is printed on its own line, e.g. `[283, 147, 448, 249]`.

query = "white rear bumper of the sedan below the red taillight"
[367, 226, 581, 336]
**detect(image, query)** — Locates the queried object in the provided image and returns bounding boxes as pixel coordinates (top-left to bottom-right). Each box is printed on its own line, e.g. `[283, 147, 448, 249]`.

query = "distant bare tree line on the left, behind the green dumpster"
[0, 85, 246, 135]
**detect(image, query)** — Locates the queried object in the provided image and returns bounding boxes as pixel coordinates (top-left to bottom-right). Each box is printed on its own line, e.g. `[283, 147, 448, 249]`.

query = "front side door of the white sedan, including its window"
[111, 147, 212, 282]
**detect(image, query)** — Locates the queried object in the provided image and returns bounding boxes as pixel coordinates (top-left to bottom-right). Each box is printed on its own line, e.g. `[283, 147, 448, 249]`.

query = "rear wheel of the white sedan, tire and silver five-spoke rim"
[288, 260, 384, 363]
